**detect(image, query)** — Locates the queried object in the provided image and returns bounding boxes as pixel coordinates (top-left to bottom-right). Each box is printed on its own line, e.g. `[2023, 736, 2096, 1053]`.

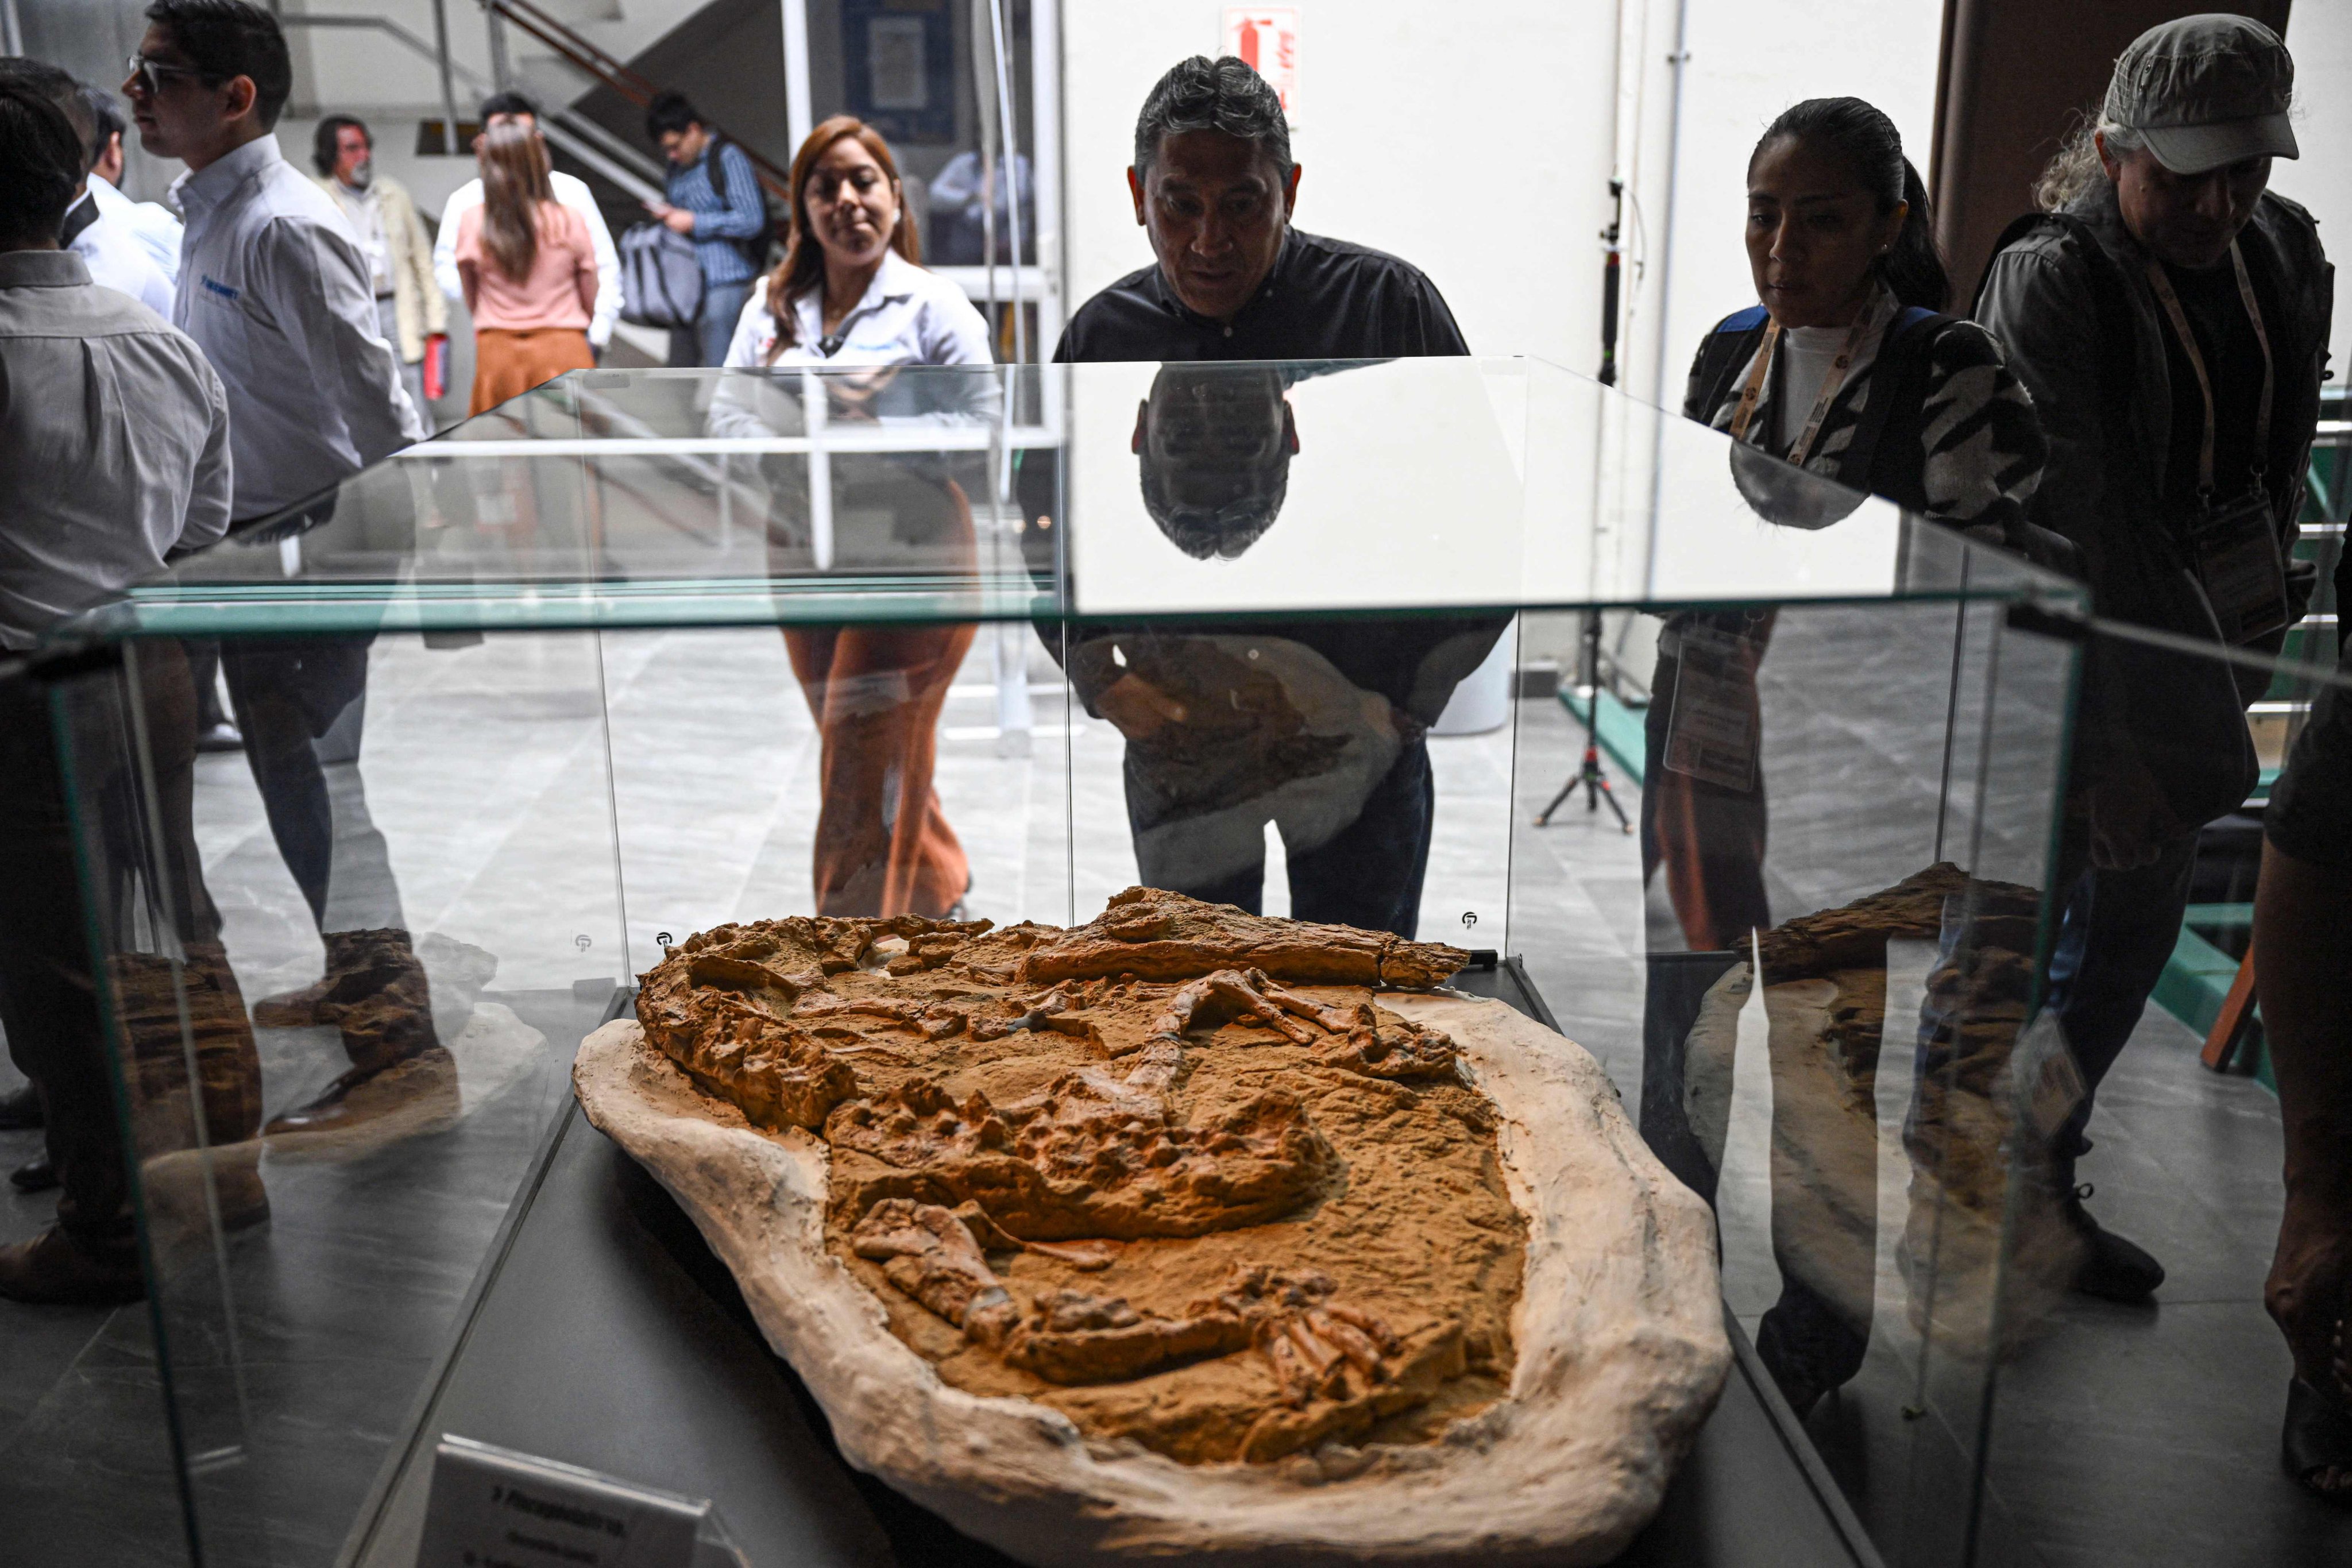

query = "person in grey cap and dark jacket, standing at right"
[1976, 14, 2333, 1300]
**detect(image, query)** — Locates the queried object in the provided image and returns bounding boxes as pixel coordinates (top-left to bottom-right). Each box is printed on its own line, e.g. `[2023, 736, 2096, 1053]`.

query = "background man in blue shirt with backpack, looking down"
[644, 92, 767, 364]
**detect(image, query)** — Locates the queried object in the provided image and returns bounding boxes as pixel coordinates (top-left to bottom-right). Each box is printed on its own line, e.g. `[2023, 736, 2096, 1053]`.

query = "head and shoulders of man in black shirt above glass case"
[1054, 54, 1470, 362]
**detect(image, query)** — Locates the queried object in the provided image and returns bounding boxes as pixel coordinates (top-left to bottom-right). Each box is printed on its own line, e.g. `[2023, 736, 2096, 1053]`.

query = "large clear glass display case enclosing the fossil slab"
[0, 360, 2086, 1568]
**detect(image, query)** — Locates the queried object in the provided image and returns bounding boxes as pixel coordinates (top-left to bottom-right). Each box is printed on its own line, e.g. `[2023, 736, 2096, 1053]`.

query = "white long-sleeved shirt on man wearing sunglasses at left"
[172, 136, 426, 517]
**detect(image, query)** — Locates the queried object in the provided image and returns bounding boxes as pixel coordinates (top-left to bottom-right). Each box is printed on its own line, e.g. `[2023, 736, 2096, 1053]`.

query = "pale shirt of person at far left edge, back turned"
[0, 252, 230, 649]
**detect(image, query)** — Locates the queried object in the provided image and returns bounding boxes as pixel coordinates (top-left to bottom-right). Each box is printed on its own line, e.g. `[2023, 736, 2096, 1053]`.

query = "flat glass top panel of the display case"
[73, 360, 2072, 635]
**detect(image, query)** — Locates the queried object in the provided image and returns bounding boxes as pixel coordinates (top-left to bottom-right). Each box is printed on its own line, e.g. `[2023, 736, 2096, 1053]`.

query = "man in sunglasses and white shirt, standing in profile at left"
[122, 0, 456, 1136]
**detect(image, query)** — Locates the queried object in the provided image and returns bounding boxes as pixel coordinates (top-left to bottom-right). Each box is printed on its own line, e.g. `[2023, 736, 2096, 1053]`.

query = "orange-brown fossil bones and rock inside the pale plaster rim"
[638, 889, 1524, 1462]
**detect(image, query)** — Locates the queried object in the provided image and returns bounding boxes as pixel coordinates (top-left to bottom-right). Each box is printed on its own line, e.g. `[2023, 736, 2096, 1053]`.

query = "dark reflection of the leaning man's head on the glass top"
[1134, 364, 1298, 559]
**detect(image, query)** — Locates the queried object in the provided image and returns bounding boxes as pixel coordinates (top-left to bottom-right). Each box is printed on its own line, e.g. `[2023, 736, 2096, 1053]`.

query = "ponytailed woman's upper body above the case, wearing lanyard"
[1684, 99, 2046, 536]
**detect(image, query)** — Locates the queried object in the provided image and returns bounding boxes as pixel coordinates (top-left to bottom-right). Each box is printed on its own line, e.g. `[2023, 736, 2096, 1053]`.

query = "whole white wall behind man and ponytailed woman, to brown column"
[1063, 0, 1942, 392]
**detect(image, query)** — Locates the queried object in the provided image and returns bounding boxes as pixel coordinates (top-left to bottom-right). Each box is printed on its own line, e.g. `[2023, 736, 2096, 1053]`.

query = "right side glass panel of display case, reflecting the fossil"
[1510, 592, 2075, 1563]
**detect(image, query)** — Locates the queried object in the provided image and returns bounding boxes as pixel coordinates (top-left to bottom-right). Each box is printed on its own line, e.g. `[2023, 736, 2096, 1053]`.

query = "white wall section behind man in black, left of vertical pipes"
[1063, 0, 1616, 372]
